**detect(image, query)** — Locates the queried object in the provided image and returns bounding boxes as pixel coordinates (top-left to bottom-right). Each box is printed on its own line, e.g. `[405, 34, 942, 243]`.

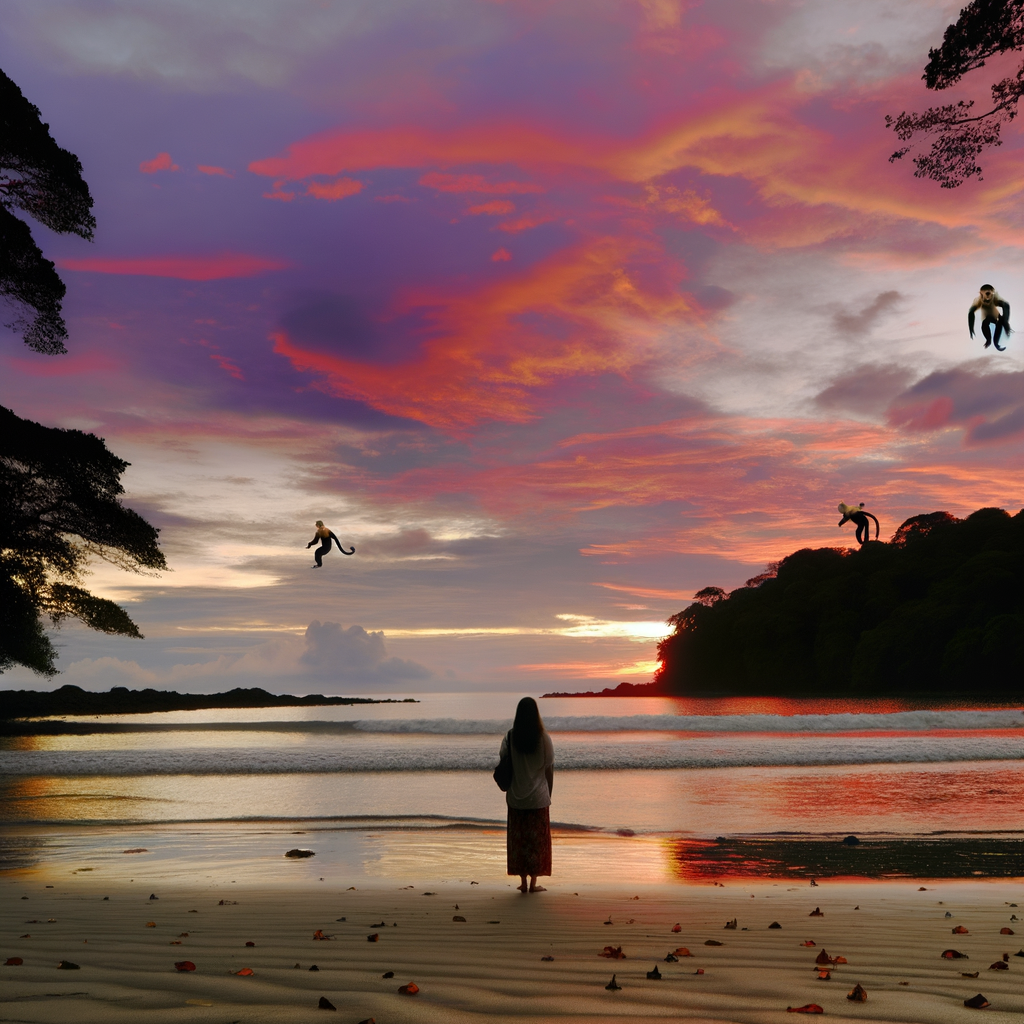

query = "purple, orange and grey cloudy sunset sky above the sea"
[0, 0, 1024, 693]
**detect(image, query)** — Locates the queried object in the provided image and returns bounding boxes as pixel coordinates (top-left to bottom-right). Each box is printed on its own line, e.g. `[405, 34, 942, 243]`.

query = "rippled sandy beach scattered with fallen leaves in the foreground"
[0, 872, 1024, 1024]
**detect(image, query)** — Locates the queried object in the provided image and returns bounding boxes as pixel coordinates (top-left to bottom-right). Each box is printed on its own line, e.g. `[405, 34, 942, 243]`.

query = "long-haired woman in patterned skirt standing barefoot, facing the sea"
[500, 697, 555, 893]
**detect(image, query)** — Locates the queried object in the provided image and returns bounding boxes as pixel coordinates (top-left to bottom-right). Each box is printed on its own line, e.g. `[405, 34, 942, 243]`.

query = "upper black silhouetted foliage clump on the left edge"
[0, 71, 96, 354]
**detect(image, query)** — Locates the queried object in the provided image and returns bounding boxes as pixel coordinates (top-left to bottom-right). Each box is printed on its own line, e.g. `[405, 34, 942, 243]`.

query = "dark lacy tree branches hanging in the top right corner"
[886, 0, 1024, 188]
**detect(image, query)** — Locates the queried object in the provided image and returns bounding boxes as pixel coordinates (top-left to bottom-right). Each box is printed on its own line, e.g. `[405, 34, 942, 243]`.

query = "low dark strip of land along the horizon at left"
[0, 686, 417, 724]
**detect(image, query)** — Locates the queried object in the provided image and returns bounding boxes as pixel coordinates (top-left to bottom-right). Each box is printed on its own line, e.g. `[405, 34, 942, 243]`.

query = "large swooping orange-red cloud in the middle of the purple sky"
[273, 239, 696, 432]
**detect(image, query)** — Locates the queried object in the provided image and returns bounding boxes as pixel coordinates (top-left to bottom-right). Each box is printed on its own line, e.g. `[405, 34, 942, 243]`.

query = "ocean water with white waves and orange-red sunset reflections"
[0, 693, 1024, 881]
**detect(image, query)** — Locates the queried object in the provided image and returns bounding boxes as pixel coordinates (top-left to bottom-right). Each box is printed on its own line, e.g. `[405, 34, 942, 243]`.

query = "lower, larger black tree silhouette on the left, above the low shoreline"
[0, 407, 167, 675]
